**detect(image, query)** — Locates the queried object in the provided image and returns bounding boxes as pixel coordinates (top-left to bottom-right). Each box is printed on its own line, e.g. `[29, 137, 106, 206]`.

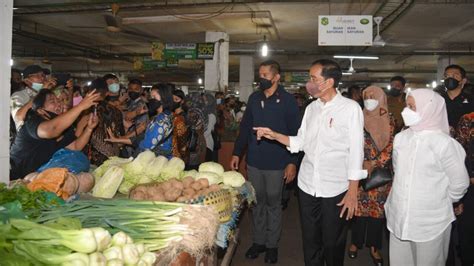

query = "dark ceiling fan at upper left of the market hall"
[69, 3, 157, 41]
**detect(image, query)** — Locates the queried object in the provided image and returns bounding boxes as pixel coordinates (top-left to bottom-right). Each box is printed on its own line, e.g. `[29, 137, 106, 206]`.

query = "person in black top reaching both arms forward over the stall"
[10, 89, 100, 180]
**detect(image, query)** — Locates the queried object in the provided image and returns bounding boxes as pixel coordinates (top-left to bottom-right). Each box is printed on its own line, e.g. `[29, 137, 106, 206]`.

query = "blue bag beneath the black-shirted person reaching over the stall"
[38, 149, 90, 174]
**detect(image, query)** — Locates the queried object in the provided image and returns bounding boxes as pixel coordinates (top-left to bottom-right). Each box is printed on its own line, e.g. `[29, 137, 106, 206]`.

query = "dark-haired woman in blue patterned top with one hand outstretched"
[105, 84, 174, 159]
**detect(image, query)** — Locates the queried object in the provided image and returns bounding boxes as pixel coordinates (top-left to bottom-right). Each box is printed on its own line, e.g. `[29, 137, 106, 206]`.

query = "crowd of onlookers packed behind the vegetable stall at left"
[10, 68, 245, 179]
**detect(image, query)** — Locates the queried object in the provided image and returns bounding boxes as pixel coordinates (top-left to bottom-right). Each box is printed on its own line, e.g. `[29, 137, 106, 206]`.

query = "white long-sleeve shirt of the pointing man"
[289, 93, 367, 198]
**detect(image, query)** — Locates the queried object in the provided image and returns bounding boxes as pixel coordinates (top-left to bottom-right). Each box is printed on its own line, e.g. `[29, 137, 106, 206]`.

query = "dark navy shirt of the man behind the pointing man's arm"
[233, 85, 301, 170]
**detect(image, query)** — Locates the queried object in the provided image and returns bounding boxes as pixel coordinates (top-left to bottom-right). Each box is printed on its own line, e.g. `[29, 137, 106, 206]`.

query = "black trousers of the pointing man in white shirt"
[299, 189, 347, 266]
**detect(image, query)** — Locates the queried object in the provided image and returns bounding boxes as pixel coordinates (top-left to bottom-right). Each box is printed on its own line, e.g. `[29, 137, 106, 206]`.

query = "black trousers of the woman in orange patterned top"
[351, 217, 385, 250]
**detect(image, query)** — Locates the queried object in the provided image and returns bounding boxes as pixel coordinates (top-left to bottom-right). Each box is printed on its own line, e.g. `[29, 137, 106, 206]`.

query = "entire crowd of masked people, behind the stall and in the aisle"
[10, 59, 474, 266]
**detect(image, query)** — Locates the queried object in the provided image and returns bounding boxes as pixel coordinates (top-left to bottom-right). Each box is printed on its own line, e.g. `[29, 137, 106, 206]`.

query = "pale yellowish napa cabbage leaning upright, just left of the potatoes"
[92, 166, 123, 199]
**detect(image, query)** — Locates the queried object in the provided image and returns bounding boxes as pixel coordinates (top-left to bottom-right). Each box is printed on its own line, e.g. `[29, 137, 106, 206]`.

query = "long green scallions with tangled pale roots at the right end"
[37, 199, 219, 256]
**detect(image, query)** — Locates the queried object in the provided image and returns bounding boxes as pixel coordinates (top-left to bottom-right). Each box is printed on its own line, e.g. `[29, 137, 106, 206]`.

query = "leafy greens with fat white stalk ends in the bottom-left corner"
[0, 219, 156, 266]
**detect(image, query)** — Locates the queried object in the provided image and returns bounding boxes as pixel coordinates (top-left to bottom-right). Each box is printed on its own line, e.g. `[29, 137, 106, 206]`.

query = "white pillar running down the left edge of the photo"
[0, 0, 13, 183]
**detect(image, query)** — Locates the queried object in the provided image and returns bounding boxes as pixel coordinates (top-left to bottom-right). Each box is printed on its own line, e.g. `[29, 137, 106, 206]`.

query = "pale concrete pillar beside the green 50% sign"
[204, 31, 229, 91]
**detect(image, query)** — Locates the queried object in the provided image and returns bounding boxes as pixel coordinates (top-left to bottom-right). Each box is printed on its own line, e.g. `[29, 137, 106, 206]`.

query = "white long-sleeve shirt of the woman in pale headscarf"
[385, 129, 469, 242]
